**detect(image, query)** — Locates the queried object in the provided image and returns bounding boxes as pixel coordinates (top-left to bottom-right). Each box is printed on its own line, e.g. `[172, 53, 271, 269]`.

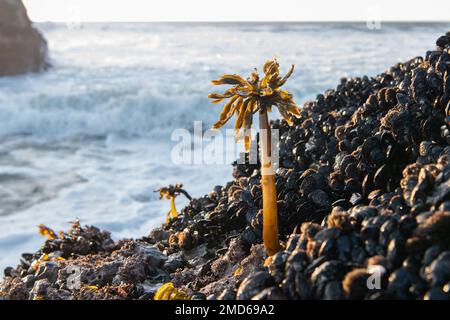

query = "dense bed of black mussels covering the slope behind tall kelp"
[154, 34, 450, 299]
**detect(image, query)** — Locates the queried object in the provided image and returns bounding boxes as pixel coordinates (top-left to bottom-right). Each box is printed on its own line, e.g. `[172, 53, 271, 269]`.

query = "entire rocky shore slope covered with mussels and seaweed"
[0, 33, 450, 300]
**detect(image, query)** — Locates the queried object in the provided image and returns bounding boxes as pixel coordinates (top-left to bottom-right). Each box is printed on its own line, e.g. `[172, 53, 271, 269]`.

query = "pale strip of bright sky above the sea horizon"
[23, 0, 450, 22]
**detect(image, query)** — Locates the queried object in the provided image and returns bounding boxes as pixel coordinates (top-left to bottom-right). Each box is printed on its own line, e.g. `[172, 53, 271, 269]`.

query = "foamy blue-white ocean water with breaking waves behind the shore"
[0, 23, 450, 269]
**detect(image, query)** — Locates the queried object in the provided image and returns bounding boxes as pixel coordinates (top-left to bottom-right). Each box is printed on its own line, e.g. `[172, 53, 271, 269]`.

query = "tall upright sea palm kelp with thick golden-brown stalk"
[208, 59, 300, 255]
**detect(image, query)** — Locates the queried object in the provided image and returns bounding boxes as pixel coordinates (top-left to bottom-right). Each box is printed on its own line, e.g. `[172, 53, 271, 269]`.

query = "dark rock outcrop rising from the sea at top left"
[0, 0, 48, 76]
